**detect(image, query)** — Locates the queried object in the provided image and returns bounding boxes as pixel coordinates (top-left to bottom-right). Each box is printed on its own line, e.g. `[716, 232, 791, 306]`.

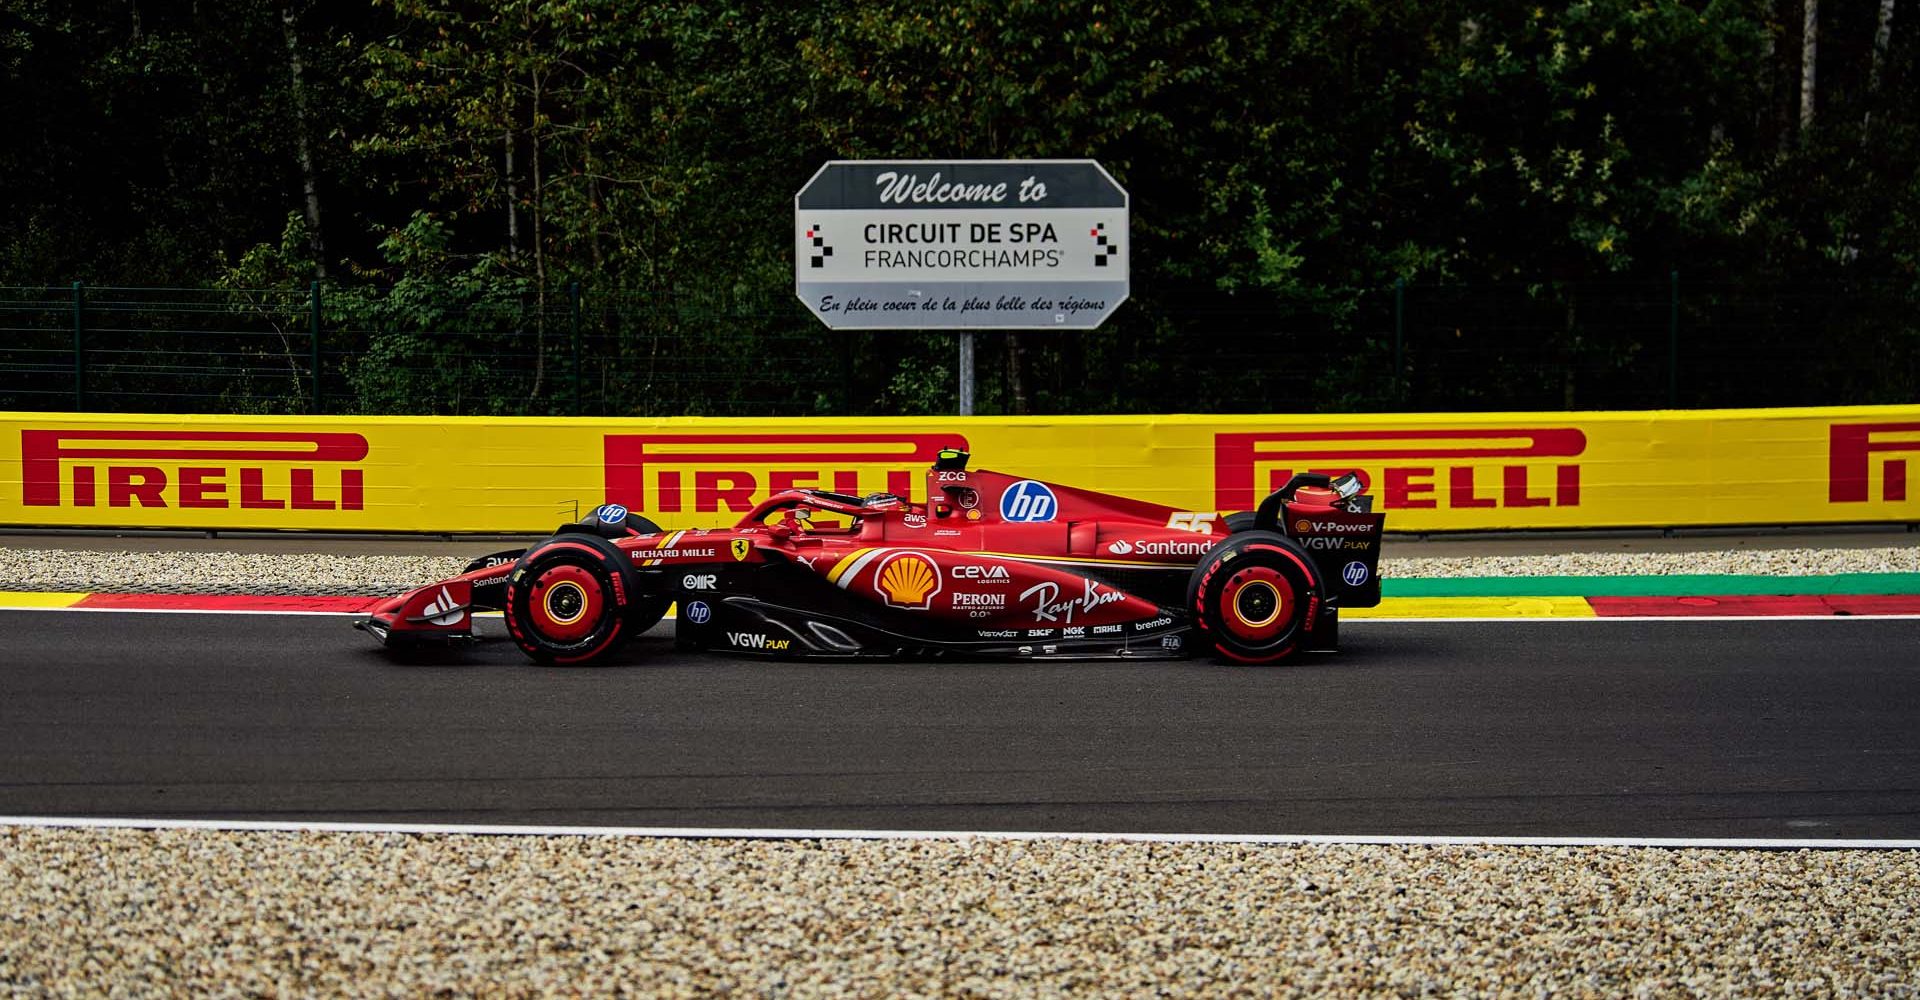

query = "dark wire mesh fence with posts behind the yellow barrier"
[0, 273, 1920, 417]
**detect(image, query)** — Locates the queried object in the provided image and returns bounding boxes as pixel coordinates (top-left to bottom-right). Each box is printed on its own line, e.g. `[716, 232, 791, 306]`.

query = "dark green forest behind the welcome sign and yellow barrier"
[0, 0, 1920, 415]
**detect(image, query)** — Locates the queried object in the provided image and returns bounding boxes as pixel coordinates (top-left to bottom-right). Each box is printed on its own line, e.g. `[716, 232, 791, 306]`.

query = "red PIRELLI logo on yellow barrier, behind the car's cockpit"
[607, 434, 968, 514]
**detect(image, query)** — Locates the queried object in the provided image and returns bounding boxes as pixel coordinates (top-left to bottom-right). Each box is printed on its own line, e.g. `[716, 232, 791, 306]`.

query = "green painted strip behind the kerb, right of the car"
[1380, 572, 1920, 597]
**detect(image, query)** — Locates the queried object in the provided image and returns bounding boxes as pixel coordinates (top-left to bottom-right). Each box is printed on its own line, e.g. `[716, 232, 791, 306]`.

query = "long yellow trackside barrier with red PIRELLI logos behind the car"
[0, 407, 1920, 532]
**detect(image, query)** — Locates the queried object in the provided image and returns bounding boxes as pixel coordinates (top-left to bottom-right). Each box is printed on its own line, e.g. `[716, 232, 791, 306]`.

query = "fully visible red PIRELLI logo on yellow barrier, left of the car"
[19, 430, 367, 511]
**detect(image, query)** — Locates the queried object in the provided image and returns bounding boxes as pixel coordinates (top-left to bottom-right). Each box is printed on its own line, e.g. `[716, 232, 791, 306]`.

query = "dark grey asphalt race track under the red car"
[0, 610, 1920, 839]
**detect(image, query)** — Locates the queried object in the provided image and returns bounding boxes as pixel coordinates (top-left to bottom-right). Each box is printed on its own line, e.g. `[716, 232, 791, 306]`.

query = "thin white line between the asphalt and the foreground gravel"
[0, 816, 1920, 850]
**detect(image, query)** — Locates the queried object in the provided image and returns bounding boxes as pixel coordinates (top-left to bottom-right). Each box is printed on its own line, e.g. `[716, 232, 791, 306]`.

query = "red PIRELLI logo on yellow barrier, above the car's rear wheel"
[1213, 428, 1586, 511]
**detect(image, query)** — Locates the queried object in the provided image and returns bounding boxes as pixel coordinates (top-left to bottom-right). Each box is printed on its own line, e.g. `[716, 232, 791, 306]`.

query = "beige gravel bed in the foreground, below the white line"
[0, 827, 1920, 996]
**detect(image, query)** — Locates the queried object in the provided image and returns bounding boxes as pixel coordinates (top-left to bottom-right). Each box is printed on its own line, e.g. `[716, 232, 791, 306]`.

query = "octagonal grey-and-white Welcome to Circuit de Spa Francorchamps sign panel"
[793, 159, 1131, 330]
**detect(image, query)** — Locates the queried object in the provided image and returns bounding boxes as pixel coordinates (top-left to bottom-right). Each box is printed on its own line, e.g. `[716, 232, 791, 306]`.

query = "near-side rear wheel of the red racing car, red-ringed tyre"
[1187, 532, 1321, 664]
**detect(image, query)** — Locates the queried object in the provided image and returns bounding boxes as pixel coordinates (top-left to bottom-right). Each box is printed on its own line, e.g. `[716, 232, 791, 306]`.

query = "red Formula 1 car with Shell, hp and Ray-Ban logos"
[355, 451, 1386, 664]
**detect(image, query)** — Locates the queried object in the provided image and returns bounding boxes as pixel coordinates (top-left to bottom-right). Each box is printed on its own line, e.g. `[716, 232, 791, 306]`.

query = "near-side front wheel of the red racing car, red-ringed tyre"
[503, 534, 645, 664]
